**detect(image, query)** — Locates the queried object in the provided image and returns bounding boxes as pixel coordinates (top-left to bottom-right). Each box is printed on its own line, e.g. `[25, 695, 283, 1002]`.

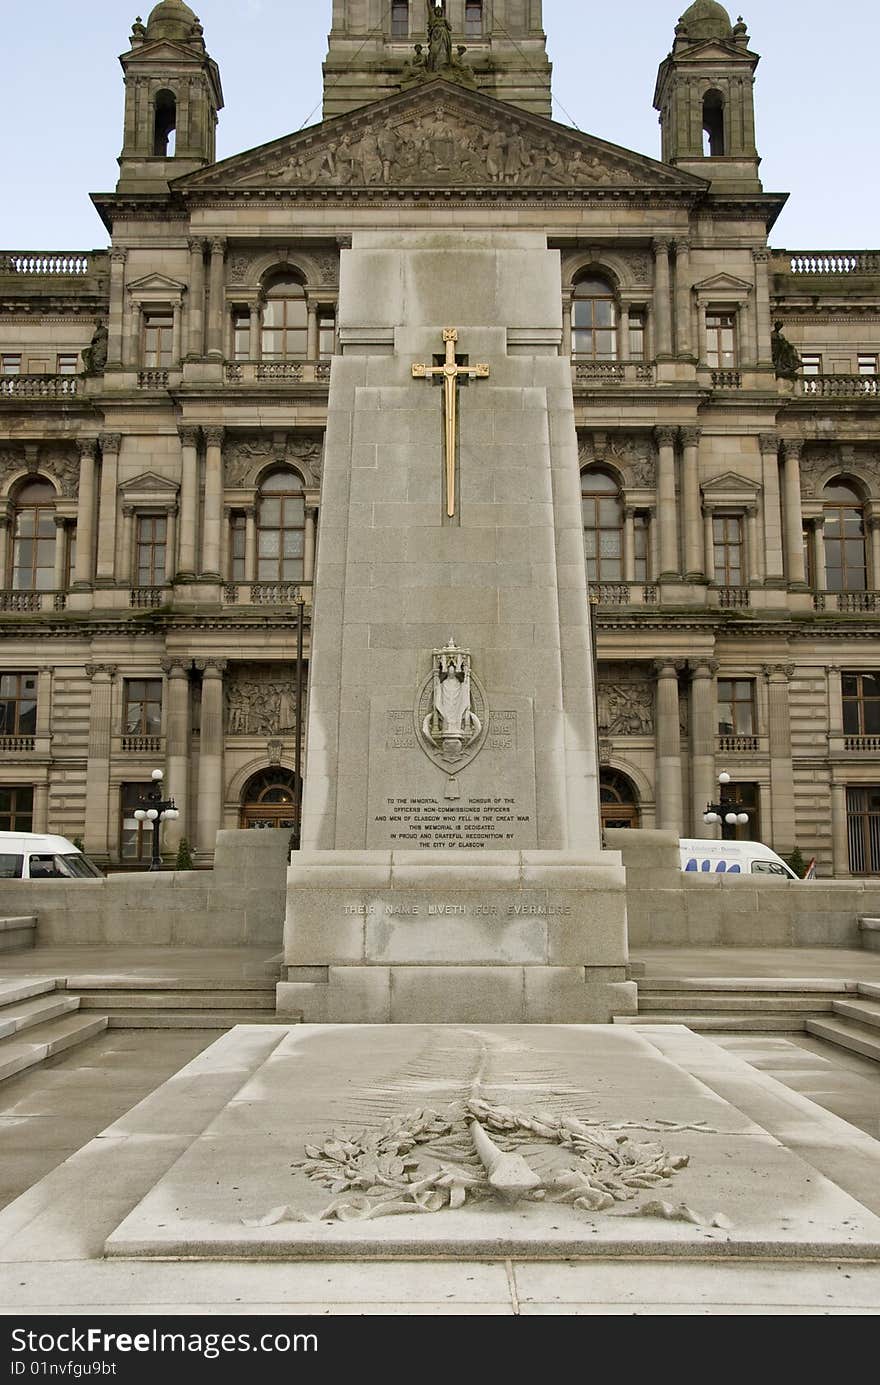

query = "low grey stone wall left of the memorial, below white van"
[0, 830, 290, 949]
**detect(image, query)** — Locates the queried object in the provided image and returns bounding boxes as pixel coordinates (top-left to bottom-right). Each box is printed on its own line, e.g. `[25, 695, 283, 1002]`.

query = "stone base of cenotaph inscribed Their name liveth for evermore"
[277, 850, 636, 1024]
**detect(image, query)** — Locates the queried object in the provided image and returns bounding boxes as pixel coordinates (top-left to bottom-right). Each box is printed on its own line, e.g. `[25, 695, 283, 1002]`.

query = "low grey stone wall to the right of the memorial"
[606, 831, 880, 949]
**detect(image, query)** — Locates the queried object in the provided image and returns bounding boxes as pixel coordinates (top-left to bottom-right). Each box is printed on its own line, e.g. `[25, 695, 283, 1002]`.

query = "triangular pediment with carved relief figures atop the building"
[173, 80, 708, 195]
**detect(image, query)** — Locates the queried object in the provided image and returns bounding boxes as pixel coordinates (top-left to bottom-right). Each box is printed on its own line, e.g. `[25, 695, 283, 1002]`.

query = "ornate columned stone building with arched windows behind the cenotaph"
[0, 0, 880, 877]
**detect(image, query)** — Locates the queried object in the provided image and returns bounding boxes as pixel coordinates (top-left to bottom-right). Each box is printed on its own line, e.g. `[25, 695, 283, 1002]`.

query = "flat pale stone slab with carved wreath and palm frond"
[105, 1025, 880, 1260]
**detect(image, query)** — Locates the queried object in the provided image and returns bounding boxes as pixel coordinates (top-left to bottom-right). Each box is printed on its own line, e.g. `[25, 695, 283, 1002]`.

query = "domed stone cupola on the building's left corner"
[116, 0, 223, 193]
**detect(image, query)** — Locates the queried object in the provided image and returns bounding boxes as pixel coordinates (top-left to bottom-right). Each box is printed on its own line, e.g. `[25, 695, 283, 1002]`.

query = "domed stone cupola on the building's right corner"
[654, 0, 761, 193]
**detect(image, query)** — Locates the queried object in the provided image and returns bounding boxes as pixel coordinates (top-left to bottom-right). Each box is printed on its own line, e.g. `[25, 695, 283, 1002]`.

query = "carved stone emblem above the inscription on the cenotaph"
[416, 638, 489, 796]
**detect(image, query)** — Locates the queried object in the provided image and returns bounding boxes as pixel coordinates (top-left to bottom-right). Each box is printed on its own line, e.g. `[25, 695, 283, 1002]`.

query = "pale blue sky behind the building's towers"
[0, 0, 880, 249]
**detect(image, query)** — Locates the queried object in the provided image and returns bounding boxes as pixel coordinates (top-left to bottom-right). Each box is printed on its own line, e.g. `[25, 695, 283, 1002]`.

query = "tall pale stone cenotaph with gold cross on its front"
[279, 230, 635, 1024]
